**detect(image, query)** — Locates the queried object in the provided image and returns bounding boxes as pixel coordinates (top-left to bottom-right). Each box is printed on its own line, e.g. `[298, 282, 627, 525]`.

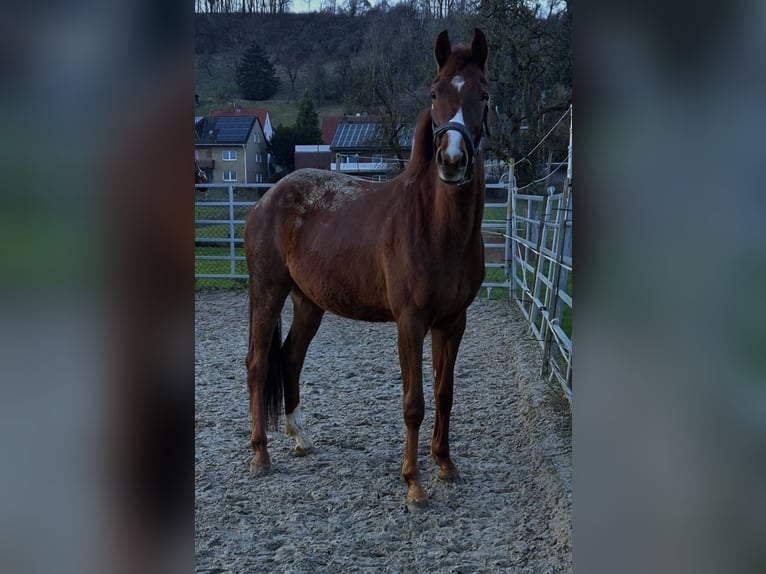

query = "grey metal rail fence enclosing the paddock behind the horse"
[195, 174, 572, 399]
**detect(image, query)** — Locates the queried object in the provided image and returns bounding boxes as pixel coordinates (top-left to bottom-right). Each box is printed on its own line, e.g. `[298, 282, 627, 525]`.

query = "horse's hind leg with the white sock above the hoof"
[282, 288, 324, 455]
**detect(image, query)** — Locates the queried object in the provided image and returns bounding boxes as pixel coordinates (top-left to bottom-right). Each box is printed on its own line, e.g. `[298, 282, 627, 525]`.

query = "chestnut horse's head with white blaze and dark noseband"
[431, 28, 489, 184]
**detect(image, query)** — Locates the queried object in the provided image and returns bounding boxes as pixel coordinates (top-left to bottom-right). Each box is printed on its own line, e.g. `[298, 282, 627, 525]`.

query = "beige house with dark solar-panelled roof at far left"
[194, 112, 272, 183]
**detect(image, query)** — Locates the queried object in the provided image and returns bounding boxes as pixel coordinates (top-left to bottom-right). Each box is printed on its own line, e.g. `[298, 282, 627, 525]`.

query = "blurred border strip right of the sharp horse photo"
[573, 0, 766, 574]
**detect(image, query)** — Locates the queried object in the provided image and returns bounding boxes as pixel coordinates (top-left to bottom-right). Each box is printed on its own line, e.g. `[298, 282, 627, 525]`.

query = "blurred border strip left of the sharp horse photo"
[0, 0, 194, 572]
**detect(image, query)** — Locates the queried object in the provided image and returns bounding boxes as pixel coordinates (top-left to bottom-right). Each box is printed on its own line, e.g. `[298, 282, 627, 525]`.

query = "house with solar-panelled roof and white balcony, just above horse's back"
[330, 115, 414, 181]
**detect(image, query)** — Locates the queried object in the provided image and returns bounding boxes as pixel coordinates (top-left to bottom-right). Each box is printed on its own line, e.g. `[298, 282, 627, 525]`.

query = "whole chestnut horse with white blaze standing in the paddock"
[244, 29, 489, 509]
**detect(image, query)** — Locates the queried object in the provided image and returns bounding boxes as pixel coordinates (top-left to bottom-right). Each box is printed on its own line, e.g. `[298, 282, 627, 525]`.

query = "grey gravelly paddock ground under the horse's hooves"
[195, 291, 572, 574]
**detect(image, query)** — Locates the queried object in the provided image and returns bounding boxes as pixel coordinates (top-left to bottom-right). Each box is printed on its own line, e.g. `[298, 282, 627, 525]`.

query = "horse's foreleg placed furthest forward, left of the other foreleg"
[397, 317, 428, 510]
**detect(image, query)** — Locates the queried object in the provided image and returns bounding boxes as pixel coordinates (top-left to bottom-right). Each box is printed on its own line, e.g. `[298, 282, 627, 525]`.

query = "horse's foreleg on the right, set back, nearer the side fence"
[431, 311, 465, 481]
